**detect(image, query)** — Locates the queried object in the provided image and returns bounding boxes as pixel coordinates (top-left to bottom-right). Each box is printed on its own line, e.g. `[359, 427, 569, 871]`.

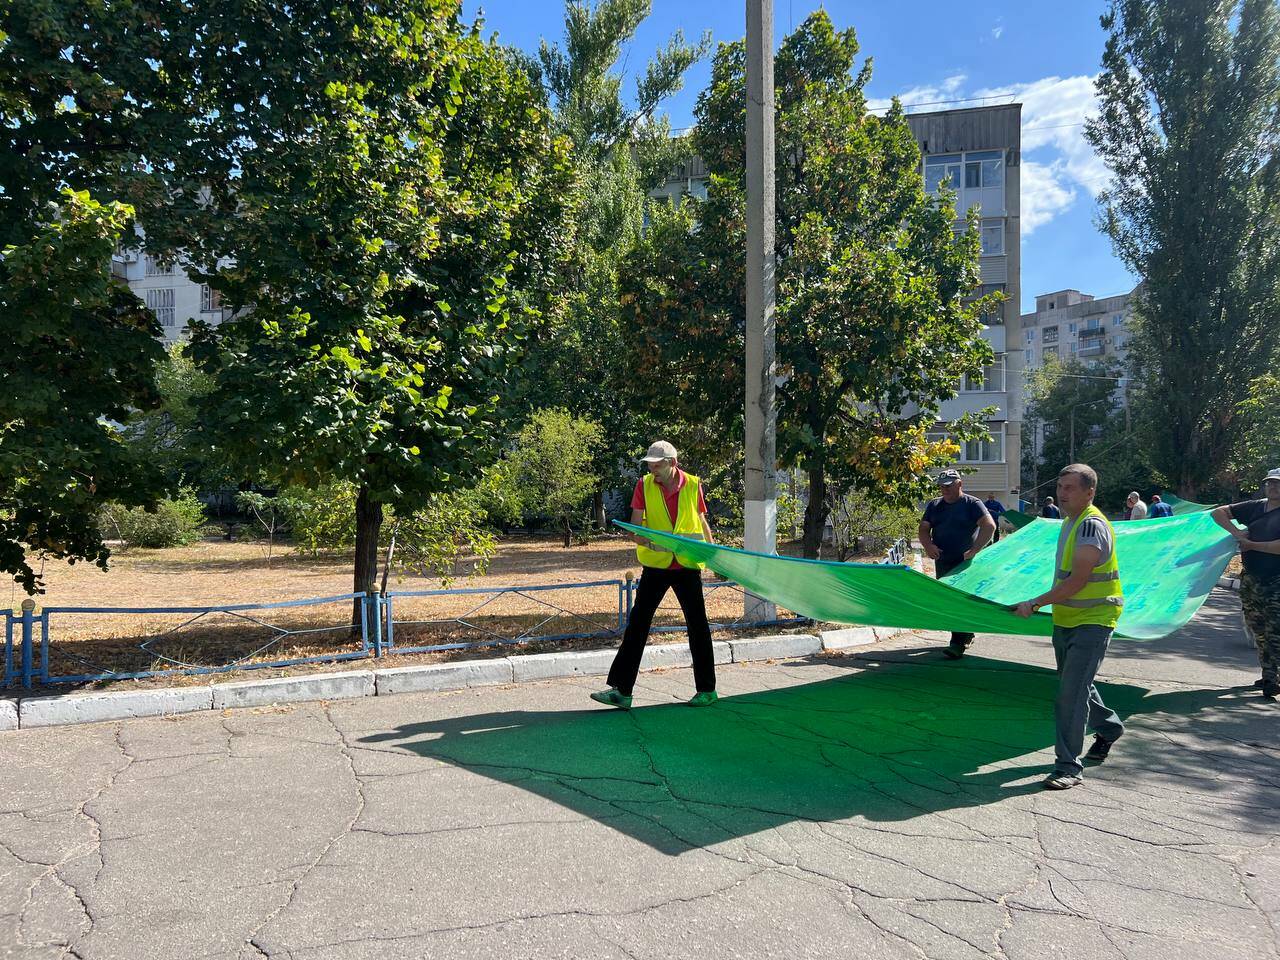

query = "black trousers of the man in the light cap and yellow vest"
[608, 567, 716, 696]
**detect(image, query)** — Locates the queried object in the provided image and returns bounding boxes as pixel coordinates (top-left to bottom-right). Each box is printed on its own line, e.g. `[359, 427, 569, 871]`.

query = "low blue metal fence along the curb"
[0, 577, 809, 690]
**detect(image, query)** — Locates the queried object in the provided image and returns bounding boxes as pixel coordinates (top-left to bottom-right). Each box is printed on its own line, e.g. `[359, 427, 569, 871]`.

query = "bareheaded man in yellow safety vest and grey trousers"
[1016, 463, 1124, 790]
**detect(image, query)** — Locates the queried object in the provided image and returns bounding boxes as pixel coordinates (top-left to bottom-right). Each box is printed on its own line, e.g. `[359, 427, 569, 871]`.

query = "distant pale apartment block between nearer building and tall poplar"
[1021, 288, 1137, 369]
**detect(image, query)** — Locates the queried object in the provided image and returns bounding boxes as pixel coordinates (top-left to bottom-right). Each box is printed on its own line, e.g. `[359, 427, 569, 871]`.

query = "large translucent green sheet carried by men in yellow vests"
[620, 513, 1235, 640]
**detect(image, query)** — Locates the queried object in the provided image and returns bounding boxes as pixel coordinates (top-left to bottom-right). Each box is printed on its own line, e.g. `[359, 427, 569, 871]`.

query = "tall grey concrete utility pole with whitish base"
[744, 0, 778, 620]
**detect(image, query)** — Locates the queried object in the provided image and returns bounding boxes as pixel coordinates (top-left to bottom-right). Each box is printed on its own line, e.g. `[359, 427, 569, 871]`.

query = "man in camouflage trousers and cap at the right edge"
[1213, 467, 1280, 698]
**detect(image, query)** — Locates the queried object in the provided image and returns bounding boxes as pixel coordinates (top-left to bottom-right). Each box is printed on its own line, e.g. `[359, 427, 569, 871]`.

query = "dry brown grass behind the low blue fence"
[13, 536, 849, 684]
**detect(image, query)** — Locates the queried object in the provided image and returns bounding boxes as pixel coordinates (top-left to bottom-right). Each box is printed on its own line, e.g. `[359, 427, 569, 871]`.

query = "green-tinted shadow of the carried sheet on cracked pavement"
[361, 650, 1274, 854]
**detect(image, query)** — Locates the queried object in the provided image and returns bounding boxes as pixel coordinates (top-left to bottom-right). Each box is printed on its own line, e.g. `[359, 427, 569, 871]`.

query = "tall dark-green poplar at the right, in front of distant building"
[1085, 0, 1280, 499]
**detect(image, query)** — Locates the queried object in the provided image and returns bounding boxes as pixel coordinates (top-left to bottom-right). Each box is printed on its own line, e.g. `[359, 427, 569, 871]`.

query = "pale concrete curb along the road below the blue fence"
[0, 627, 849, 731]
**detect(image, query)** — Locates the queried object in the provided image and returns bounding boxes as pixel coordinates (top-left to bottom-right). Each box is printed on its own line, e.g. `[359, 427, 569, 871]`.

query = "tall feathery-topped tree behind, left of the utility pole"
[512, 0, 709, 527]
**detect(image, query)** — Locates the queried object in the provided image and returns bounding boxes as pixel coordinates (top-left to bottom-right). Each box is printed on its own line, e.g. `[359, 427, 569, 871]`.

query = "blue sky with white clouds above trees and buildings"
[465, 0, 1135, 312]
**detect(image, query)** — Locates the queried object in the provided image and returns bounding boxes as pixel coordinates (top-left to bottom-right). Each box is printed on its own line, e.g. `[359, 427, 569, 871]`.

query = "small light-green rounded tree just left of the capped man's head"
[506, 410, 604, 547]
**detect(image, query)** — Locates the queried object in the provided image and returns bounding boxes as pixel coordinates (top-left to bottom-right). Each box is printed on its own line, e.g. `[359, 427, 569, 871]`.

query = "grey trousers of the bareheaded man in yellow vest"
[1053, 623, 1124, 774]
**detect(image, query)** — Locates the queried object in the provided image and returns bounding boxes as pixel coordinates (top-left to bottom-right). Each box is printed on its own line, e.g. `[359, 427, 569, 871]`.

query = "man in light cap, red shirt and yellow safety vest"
[591, 440, 716, 710]
